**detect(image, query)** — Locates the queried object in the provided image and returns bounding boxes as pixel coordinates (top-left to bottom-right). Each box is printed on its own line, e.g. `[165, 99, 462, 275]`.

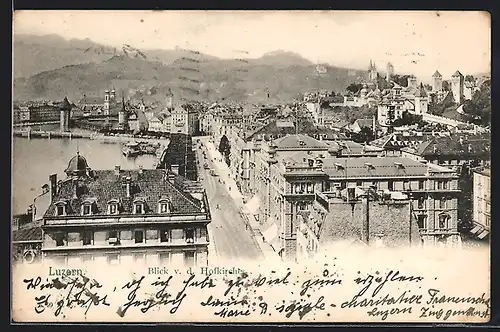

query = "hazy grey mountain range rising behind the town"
[13, 35, 365, 102]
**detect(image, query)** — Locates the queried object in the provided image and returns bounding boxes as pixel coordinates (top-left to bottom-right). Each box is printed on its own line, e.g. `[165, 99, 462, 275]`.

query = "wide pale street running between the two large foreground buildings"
[196, 137, 264, 261]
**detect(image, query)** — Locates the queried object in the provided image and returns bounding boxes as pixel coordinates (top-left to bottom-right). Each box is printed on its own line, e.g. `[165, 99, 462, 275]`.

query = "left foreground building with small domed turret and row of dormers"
[42, 155, 211, 266]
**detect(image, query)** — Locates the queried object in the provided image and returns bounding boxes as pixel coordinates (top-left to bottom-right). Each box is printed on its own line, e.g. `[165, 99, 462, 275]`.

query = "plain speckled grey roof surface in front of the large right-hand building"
[319, 201, 420, 247]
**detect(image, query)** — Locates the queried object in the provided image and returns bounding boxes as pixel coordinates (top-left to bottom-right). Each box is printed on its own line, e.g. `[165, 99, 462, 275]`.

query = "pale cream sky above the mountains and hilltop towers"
[13, 10, 491, 79]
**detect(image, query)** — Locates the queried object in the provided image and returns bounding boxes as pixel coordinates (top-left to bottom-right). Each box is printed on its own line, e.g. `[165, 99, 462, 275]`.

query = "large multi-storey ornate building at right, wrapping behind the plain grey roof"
[258, 152, 460, 259]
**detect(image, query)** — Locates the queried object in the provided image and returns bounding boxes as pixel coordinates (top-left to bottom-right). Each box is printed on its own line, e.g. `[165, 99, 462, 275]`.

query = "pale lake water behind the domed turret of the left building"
[12, 137, 156, 214]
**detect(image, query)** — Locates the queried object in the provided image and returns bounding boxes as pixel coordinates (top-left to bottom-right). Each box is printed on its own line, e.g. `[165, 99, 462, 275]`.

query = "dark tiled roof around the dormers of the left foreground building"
[45, 169, 202, 217]
